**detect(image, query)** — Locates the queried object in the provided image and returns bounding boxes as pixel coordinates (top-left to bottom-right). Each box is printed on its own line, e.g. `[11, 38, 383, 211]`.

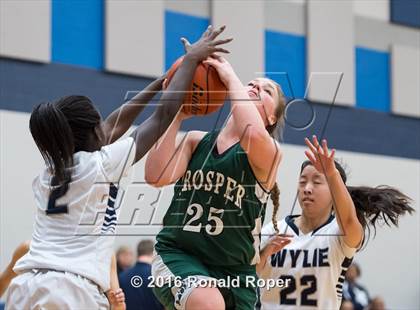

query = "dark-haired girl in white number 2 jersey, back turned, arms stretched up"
[7, 27, 230, 309]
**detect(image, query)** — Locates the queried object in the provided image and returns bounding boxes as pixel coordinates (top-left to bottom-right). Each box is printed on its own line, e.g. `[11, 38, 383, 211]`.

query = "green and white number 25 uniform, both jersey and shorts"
[152, 131, 268, 309]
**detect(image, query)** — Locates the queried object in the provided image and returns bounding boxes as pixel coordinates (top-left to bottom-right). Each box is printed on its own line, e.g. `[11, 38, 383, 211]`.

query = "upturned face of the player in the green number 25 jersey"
[246, 78, 279, 127]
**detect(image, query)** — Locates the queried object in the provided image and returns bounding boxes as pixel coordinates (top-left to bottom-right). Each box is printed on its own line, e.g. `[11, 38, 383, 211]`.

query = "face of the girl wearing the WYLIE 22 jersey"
[298, 165, 332, 218]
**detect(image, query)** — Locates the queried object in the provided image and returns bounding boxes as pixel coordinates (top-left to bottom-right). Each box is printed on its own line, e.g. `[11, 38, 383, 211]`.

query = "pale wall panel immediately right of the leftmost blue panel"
[105, 0, 164, 77]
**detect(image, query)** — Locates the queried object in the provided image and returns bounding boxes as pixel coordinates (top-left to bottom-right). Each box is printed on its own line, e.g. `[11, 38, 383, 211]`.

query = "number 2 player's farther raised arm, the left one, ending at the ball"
[102, 74, 166, 144]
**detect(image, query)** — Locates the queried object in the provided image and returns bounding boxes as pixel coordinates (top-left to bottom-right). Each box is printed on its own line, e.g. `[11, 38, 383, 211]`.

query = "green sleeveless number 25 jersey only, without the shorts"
[156, 131, 269, 266]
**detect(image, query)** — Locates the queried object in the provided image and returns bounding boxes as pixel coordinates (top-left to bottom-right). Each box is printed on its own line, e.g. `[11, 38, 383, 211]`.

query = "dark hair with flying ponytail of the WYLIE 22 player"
[300, 160, 414, 248]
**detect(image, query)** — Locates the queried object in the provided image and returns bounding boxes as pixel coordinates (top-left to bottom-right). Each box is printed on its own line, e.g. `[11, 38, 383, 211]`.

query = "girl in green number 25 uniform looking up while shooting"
[145, 57, 285, 310]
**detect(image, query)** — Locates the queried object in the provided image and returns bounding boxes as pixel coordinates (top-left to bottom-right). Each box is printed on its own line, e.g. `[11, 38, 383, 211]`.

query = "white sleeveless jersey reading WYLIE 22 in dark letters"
[260, 215, 356, 310]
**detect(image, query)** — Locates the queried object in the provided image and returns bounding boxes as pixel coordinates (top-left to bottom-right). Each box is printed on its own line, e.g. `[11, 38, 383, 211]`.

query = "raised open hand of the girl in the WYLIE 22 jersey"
[305, 135, 336, 176]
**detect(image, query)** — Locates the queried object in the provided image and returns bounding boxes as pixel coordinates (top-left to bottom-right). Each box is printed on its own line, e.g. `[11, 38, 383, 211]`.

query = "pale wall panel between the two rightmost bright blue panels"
[307, 1, 355, 105]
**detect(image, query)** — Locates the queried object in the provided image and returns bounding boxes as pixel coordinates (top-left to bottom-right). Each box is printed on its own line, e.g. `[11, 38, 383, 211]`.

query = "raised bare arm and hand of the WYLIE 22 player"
[305, 136, 363, 248]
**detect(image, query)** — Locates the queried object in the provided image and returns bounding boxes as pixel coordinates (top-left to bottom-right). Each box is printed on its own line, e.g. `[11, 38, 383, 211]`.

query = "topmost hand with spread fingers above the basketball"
[181, 25, 233, 62]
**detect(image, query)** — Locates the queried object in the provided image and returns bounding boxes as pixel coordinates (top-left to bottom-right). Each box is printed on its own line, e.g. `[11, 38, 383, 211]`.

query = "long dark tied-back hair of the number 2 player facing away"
[29, 96, 101, 185]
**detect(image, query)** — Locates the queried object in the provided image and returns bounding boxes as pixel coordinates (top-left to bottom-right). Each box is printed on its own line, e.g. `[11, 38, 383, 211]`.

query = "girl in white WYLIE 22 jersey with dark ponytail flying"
[258, 136, 414, 309]
